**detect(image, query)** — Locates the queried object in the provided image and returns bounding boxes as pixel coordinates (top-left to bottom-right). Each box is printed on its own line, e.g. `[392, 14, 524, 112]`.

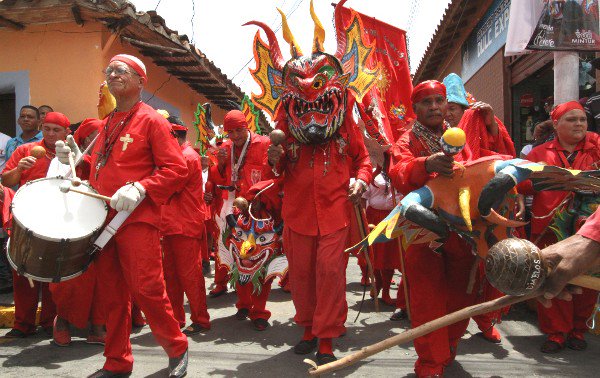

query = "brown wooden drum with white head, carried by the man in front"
[7, 177, 108, 282]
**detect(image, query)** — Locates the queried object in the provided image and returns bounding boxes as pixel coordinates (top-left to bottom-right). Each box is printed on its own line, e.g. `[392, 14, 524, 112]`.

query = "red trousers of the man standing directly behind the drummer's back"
[162, 234, 210, 328]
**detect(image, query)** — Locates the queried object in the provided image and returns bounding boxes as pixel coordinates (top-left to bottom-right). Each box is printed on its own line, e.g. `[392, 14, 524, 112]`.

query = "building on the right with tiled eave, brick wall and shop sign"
[413, 0, 596, 151]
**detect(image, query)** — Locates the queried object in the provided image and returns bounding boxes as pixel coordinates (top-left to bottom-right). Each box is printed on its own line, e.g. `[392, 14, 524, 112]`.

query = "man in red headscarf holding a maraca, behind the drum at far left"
[2, 112, 70, 338]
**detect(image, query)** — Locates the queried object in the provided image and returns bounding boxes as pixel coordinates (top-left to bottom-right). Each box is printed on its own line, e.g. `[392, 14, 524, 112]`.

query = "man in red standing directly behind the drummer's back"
[161, 116, 210, 336]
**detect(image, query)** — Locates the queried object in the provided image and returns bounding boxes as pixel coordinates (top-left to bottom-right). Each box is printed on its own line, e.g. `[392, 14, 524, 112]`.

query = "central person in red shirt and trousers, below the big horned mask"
[269, 105, 372, 364]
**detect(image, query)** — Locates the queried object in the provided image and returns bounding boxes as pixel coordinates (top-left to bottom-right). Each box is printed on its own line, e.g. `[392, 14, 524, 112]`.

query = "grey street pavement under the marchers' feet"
[0, 258, 600, 378]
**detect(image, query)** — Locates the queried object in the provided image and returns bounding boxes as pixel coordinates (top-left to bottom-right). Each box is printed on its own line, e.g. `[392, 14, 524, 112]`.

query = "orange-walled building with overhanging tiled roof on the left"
[0, 0, 268, 140]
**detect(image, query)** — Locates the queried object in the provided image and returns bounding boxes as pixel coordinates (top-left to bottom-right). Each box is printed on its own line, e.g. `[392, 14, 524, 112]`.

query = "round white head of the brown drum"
[12, 177, 108, 240]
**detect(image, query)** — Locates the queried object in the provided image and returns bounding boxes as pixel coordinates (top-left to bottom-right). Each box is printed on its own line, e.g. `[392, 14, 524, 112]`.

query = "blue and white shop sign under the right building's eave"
[461, 0, 510, 82]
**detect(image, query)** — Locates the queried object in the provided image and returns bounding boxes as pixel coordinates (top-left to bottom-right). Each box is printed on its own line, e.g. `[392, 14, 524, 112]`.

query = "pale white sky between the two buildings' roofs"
[130, 0, 450, 94]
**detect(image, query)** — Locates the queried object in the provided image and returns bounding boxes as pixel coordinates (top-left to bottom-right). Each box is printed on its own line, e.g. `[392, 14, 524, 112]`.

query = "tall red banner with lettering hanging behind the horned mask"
[340, 8, 415, 142]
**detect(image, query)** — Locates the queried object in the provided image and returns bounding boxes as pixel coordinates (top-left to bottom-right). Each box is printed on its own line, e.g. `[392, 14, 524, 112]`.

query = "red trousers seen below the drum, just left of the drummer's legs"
[50, 264, 104, 328]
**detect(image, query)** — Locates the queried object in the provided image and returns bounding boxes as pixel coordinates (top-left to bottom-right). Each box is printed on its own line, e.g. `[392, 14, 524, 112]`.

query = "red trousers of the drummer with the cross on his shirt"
[95, 223, 188, 373]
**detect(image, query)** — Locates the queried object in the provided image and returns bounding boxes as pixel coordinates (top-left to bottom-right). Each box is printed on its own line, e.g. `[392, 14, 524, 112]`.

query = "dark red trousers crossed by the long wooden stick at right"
[406, 235, 476, 376]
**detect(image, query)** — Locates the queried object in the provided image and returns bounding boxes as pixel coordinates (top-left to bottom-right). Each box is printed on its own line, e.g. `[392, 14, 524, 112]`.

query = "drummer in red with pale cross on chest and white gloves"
[57, 54, 188, 378]
